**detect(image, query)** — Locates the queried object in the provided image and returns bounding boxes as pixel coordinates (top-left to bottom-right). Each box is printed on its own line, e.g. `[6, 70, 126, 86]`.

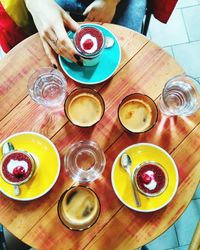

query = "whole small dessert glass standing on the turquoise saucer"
[73, 24, 105, 66]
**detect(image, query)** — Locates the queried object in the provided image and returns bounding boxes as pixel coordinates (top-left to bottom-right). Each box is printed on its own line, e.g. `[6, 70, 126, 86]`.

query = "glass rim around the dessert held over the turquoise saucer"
[73, 24, 105, 59]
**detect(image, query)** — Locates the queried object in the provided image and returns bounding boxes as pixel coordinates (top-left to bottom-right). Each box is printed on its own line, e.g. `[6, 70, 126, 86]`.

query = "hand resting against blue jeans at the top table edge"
[83, 0, 119, 23]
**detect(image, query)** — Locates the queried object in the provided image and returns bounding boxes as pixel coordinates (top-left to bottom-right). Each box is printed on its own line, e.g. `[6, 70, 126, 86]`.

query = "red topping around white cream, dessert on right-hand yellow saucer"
[136, 164, 166, 194]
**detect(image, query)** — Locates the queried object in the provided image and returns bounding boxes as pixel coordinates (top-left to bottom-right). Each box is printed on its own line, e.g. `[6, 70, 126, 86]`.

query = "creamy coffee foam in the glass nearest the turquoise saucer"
[67, 93, 103, 127]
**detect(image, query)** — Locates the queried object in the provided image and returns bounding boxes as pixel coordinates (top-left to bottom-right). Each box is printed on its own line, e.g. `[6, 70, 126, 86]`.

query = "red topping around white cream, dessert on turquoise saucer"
[75, 27, 104, 53]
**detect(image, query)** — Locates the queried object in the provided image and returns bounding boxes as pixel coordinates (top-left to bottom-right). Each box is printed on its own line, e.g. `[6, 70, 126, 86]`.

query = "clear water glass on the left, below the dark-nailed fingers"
[28, 67, 67, 107]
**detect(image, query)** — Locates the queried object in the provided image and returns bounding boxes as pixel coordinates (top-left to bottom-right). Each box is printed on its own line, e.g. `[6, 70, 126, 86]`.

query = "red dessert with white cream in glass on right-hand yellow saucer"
[134, 162, 167, 196]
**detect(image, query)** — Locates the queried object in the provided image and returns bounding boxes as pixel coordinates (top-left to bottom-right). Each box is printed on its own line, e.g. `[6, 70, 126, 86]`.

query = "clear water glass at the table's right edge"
[158, 75, 200, 116]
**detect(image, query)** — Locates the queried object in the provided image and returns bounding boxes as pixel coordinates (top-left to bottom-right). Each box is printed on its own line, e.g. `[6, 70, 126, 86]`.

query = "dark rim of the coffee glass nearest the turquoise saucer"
[64, 87, 105, 128]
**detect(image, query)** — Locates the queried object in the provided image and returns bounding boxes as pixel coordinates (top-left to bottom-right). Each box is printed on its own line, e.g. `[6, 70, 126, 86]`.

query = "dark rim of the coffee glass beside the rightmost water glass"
[117, 92, 158, 134]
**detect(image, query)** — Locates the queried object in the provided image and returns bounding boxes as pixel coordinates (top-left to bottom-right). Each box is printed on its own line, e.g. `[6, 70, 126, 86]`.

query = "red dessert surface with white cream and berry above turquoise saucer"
[74, 26, 104, 56]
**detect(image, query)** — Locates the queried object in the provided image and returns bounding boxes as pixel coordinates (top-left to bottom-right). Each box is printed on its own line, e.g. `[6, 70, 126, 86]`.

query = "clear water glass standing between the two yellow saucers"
[64, 141, 106, 182]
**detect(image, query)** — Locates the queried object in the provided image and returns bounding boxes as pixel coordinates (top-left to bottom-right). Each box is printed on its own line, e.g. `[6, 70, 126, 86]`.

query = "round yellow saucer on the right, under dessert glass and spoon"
[111, 143, 178, 212]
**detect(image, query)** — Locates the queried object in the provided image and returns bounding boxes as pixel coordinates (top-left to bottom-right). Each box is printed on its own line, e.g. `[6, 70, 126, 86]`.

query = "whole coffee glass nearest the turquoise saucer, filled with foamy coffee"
[64, 88, 105, 127]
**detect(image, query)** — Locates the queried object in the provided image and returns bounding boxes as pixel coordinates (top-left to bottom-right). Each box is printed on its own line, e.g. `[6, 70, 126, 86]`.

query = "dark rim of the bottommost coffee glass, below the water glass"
[57, 185, 101, 232]
